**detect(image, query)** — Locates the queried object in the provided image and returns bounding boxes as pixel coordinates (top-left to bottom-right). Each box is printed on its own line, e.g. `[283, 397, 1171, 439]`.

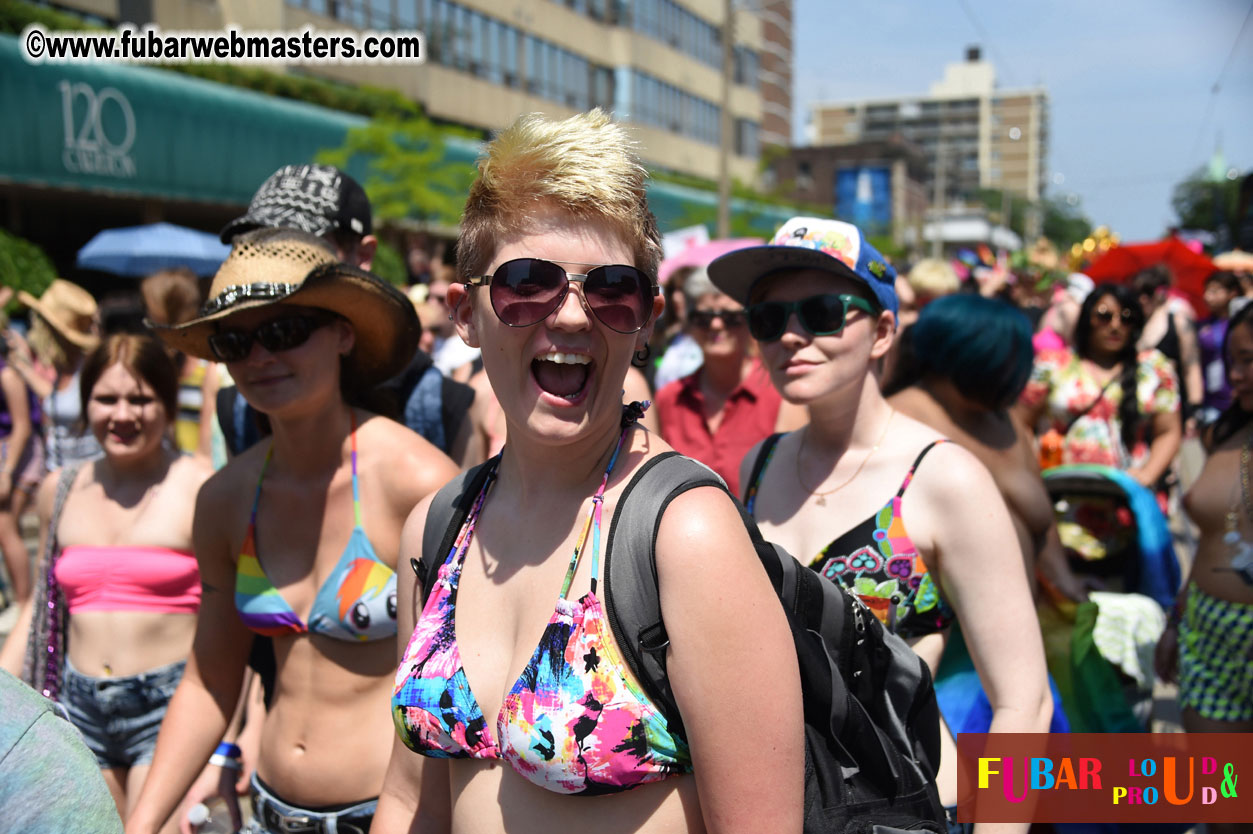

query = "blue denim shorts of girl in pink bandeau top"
[61, 657, 187, 770]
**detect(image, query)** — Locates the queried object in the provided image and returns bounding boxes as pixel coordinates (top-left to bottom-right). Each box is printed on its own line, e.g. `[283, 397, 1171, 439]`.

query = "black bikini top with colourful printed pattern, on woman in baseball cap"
[744, 436, 956, 637]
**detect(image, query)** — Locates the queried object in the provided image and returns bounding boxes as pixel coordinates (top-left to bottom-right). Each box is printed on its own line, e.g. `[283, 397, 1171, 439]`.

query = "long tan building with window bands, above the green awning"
[58, 0, 776, 183]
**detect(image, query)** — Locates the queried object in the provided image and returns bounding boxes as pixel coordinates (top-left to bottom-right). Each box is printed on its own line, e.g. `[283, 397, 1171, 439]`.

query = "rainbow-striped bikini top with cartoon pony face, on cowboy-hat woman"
[236, 418, 396, 641]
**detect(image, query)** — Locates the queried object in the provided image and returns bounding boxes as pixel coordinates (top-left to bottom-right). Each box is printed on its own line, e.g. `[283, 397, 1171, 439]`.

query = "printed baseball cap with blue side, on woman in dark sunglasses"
[709, 217, 901, 313]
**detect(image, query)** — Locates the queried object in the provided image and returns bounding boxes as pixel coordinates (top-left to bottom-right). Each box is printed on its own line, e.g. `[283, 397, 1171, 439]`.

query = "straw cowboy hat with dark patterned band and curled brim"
[148, 229, 420, 384]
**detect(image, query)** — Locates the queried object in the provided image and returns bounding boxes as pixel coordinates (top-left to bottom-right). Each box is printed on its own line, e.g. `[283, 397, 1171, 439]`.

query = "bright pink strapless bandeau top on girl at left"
[56, 545, 200, 614]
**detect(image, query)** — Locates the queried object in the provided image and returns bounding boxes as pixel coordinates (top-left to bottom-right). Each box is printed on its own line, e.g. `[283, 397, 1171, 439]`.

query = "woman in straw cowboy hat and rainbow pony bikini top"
[127, 229, 456, 834]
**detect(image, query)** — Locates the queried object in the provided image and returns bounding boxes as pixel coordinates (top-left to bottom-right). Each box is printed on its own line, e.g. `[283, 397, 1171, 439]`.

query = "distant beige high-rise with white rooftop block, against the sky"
[809, 46, 1049, 205]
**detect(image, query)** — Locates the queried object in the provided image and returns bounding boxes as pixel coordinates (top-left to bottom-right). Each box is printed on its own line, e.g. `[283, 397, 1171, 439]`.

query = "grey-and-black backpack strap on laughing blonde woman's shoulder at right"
[603, 452, 730, 735]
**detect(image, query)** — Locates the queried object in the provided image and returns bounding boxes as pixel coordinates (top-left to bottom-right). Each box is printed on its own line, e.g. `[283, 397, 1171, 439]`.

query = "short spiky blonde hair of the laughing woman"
[457, 108, 662, 284]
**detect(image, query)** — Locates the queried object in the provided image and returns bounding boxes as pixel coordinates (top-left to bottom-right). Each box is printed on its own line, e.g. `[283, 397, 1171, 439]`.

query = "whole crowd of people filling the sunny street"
[0, 111, 1253, 834]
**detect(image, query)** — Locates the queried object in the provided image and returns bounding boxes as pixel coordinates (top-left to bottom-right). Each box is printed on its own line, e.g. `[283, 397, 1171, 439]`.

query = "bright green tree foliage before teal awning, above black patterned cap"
[317, 105, 475, 225]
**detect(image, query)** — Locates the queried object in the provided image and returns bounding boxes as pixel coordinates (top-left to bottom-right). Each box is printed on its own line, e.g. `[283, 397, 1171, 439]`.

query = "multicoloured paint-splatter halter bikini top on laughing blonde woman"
[392, 430, 692, 794]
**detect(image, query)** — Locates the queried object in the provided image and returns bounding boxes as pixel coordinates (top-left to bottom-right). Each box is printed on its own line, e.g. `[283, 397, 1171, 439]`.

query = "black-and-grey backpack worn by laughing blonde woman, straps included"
[413, 452, 947, 834]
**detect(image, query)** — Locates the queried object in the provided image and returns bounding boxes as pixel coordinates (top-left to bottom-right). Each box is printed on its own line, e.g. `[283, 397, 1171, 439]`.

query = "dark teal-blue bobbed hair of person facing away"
[911, 293, 1034, 411]
